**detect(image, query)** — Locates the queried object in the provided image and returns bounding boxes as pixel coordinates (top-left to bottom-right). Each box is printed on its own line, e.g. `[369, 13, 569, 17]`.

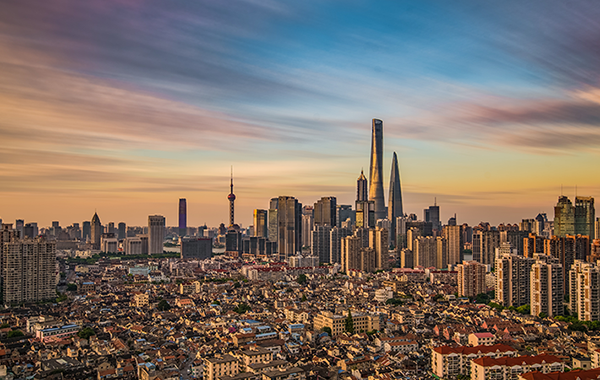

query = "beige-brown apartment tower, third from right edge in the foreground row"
[495, 242, 535, 307]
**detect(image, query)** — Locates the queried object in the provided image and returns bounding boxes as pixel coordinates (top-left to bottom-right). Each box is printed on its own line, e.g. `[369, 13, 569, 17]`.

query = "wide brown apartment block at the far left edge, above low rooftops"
[2, 238, 56, 305]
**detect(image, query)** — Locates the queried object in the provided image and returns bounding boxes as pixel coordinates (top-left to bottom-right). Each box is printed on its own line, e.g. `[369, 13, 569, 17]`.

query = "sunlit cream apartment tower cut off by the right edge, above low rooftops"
[569, 260, 600, 321]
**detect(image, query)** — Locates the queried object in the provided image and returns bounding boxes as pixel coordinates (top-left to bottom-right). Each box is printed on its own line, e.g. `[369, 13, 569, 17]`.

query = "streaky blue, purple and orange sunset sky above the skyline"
[0, 0, 600, 226]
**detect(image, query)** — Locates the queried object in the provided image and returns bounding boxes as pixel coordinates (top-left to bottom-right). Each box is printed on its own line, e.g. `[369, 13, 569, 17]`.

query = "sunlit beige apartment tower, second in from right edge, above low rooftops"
[529, 255, 564, 317]
